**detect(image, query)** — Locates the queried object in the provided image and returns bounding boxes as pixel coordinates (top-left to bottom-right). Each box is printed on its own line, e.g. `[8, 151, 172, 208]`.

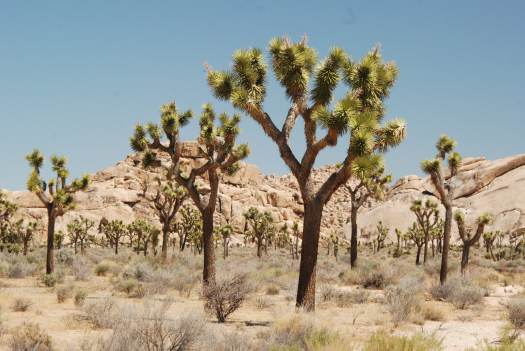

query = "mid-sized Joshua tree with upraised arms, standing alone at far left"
[26, 149, 89, 274]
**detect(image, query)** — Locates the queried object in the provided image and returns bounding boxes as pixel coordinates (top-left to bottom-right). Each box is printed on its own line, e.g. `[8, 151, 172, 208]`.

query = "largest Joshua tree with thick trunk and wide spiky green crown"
[208, 38, 405, 311]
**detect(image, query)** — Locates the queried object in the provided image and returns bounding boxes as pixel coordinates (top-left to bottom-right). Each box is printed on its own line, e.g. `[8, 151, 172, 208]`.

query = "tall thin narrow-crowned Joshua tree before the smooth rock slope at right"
[421, 135, 461, 285]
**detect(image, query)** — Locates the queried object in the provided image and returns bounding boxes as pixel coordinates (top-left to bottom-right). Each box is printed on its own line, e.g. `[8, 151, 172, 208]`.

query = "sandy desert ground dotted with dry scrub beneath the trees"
[0, 247, 525, 350]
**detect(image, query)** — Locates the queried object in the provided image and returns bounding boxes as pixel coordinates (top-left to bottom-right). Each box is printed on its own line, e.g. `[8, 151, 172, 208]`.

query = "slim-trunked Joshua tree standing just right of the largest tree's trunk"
[345, 155, 392, 267]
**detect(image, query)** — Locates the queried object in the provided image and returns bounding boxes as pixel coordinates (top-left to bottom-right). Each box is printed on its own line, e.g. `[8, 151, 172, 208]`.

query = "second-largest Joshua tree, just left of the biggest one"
[131, 102, 249, 284]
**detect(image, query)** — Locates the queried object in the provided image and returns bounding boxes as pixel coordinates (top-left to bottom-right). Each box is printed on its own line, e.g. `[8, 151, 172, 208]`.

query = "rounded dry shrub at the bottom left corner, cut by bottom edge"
[9, 323, 54, 351]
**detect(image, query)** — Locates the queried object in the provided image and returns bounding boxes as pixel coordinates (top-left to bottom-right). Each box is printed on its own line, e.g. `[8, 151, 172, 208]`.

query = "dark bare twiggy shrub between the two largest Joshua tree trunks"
[202, 275, 250, 323]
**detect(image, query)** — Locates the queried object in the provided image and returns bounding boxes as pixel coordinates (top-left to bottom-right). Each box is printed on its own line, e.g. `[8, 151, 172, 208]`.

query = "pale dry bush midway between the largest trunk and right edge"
[385, 277, 421, 325]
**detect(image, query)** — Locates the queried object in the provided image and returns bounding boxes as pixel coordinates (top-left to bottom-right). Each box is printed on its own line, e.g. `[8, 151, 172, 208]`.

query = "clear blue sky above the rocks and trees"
[0, 0, 525, 189]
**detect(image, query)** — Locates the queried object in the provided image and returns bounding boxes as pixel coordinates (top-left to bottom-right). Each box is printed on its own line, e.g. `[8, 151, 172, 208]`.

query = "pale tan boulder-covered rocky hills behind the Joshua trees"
[4, 142, 525, 246]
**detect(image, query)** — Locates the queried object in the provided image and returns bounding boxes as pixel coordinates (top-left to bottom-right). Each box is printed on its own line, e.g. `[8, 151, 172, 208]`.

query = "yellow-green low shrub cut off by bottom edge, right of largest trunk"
[363, 333, 443, 351]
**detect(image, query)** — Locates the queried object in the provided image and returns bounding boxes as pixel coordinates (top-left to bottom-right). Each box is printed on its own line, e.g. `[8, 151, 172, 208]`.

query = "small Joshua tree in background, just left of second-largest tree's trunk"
[149, 178, 188, 261]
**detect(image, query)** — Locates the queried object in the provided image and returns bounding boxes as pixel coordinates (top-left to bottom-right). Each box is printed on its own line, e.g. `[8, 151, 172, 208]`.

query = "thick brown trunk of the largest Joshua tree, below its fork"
[296, 200, 323, 311]
